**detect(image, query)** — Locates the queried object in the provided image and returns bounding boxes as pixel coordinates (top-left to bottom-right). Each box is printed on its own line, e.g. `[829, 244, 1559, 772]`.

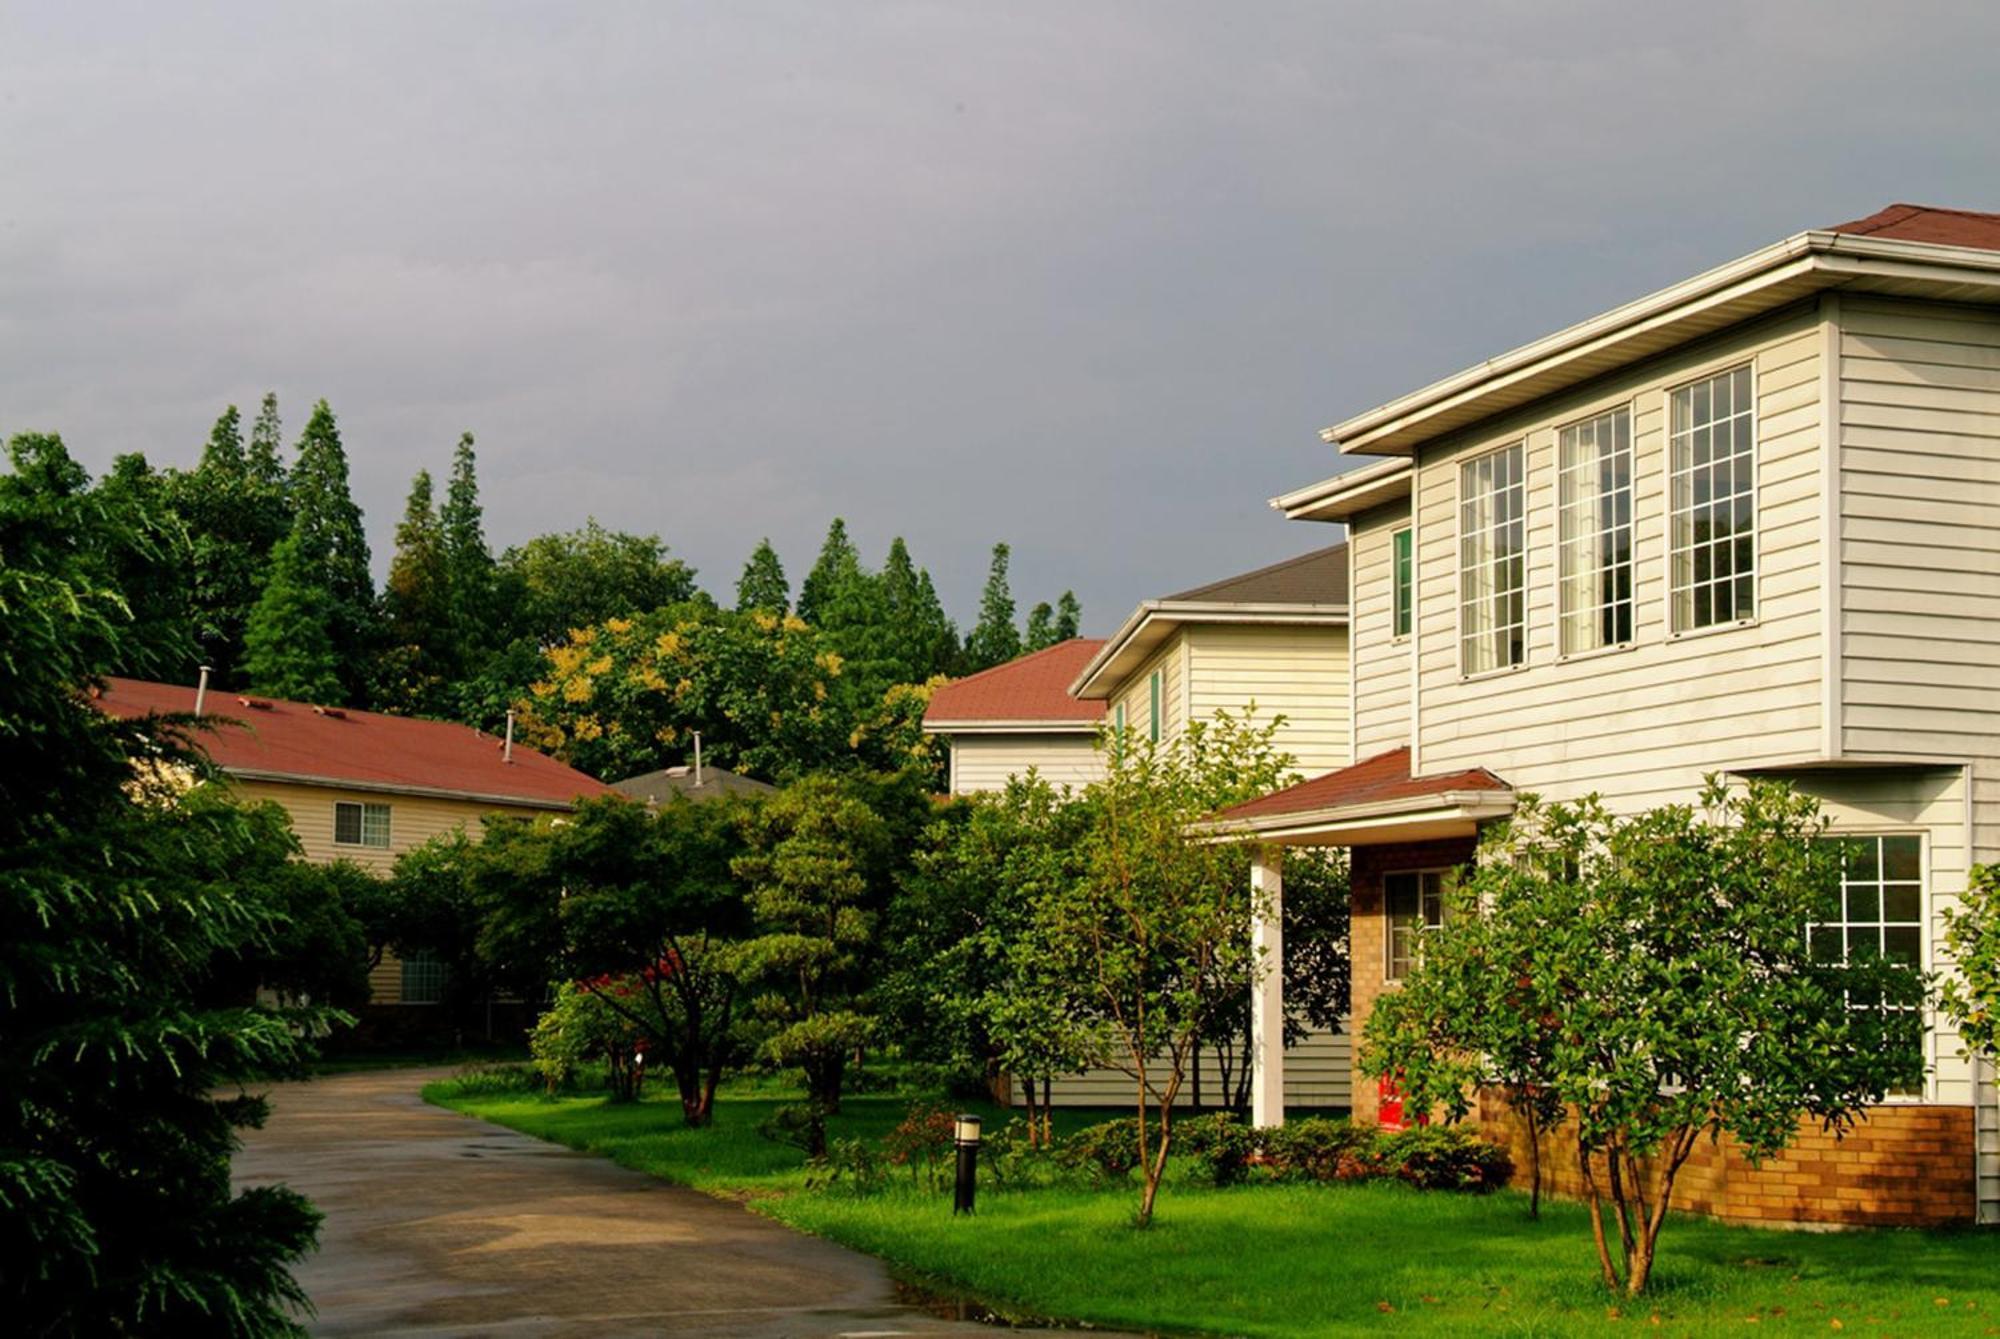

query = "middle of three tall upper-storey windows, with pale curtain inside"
[1556, 410, 1632, 656]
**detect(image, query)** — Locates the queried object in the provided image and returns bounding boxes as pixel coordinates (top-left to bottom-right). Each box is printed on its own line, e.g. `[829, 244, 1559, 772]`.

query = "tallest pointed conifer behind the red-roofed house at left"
[284, 400, 376, 703]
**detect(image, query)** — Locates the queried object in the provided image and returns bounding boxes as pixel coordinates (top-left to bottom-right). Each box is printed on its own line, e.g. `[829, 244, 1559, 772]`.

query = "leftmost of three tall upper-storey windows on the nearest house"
[1458, 444, 1528, 673]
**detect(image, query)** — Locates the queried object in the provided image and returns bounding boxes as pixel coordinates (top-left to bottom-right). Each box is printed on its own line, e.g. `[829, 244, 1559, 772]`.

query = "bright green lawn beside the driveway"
[424, 1083, 2000, 1335]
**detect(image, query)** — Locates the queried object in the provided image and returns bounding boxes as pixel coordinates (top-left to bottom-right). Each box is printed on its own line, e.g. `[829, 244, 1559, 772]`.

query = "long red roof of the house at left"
[96, 679, 610, 805]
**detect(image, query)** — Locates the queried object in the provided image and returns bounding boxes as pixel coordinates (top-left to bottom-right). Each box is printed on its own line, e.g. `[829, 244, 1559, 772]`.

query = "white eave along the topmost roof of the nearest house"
[1320, 232, 2000, 454]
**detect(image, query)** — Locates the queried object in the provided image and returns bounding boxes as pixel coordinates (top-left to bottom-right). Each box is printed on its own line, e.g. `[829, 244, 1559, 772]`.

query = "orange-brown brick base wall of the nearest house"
[1476, 1089, 1976, 1227]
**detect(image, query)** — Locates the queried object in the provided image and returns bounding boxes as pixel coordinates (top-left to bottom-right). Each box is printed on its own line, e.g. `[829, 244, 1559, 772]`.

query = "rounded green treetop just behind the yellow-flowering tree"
[500, 518, 700, 646]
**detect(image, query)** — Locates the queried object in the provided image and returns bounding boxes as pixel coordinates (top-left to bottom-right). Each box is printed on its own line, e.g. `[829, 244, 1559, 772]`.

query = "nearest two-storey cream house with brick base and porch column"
[1222, 206, 2000, 1223]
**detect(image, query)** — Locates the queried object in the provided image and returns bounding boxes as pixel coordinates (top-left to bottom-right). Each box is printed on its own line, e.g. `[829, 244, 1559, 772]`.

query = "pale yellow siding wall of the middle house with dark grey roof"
[1180, 624, 1350, 775]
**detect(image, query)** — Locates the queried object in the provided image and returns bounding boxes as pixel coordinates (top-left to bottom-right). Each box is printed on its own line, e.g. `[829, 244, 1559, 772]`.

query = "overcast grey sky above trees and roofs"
[0, 0, 2000, 632]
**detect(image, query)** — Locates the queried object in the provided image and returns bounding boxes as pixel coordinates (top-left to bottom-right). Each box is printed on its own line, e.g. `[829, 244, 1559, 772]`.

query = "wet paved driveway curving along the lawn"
[236, 1069, 1080, 1339]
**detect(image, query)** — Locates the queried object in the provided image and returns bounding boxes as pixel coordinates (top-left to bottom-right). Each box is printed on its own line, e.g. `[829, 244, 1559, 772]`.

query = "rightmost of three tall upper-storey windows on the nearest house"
[1668, 366, 1756, 632]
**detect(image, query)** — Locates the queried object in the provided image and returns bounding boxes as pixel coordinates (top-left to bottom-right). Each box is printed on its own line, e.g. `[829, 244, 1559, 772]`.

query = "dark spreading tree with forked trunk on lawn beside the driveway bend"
[474, 795, 748, 1125]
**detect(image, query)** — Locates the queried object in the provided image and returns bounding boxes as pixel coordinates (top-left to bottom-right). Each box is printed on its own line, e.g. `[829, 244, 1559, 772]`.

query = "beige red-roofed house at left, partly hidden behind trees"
[98, 677, 608, 1005]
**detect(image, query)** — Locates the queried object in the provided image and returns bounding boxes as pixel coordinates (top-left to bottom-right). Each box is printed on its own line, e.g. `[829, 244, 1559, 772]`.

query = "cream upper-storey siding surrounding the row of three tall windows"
[1408, 308, 1824, 809]
